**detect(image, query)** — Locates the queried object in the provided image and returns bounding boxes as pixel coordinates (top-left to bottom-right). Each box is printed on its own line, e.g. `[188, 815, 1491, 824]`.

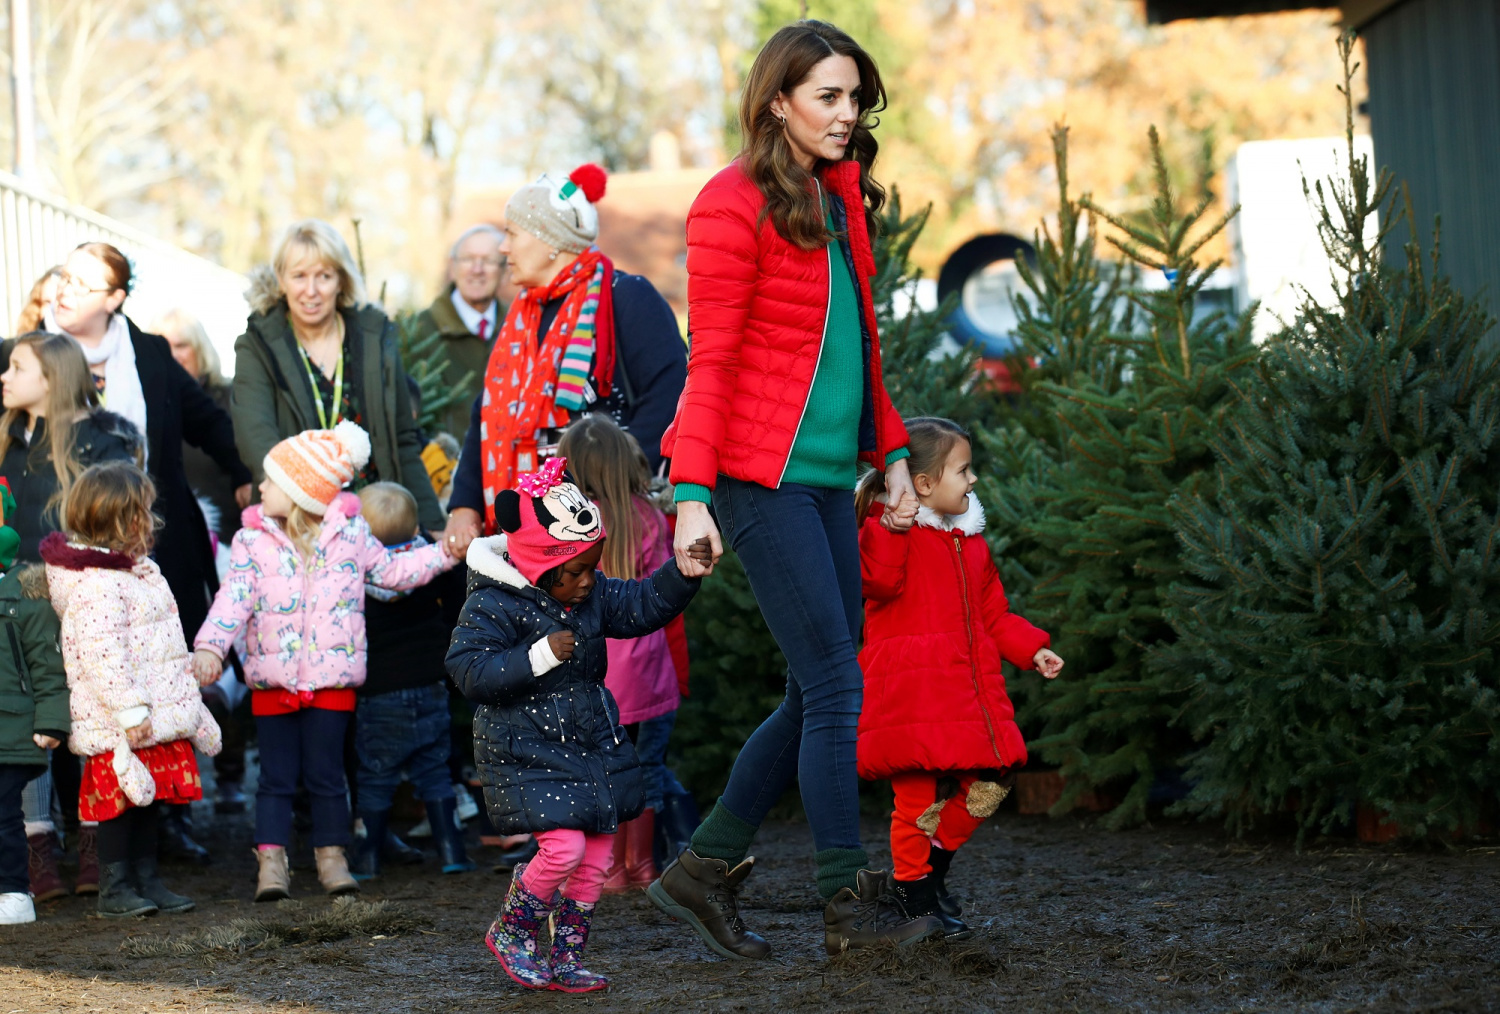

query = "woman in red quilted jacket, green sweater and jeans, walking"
[650, 21, 939, 957]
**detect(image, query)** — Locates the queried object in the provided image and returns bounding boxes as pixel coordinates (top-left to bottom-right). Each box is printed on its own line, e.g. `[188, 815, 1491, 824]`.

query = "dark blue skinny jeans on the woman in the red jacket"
[714, 476, 864, 852]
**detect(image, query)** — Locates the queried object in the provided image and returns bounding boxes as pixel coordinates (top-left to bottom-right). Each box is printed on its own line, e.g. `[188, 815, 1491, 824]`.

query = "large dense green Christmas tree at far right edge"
[1155, 38, 1500, 834]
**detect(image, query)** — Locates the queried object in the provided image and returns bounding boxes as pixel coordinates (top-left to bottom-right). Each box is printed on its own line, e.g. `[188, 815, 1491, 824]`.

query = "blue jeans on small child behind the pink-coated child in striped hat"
[354, 683, 453, 813]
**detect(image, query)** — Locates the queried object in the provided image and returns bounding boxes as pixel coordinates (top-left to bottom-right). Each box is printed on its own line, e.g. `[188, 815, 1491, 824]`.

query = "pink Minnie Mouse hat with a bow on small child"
[495, 458, 605, 584]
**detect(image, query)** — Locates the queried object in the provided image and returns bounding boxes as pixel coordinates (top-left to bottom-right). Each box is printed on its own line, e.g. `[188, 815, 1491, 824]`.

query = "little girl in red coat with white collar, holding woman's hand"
[855, 419, 1062, 939]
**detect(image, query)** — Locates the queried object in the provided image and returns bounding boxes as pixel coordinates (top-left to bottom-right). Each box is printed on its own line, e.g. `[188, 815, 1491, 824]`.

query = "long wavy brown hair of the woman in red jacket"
[740, 20, 885, 251]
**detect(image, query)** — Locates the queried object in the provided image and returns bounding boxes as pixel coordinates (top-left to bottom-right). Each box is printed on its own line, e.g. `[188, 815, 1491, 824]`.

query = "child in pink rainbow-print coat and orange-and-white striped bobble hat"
[194, 422, 458, 902]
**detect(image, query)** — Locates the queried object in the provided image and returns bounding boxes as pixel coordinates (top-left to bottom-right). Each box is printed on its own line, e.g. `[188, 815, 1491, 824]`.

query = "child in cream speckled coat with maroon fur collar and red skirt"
[41, 462, 221, 917]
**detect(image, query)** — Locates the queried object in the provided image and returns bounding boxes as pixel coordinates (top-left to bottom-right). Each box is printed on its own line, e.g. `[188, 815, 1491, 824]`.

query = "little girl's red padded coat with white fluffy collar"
[858, 494, 1052, 779]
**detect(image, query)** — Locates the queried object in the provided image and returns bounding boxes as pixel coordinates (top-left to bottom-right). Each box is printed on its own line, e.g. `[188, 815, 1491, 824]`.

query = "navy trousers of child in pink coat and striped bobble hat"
[255, 708, 354, 849]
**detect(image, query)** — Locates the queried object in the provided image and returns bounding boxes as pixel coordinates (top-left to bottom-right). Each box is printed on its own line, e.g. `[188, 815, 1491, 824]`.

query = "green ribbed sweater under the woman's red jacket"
[674, 216, 908, 504]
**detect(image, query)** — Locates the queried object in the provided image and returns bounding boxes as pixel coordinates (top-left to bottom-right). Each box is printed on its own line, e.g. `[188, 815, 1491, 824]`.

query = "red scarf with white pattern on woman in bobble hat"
[479, 246, 614, 534]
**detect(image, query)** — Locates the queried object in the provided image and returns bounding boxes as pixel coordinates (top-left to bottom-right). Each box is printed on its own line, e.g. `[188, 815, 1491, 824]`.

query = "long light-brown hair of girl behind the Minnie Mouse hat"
[558, 416, 651, 581]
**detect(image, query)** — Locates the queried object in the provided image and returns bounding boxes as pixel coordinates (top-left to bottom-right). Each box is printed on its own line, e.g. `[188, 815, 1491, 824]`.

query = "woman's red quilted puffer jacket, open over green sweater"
[662, 162, 906, 489]
